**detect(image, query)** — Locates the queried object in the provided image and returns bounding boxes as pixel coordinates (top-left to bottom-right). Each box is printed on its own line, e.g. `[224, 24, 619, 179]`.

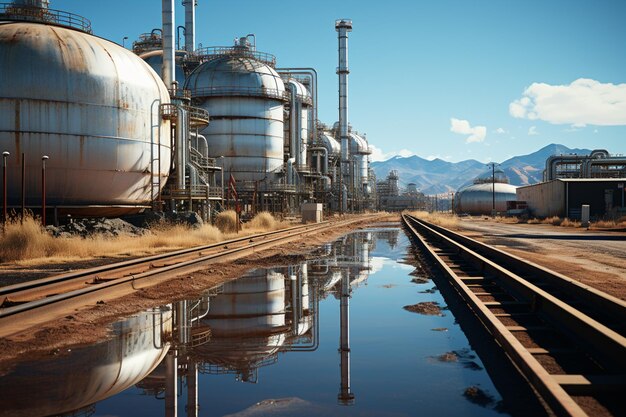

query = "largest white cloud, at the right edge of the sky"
[509, 78, 626, 127]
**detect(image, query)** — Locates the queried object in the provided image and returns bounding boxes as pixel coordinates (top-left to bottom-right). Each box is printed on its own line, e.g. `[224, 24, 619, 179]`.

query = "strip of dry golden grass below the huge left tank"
[0, 214, 224, 265]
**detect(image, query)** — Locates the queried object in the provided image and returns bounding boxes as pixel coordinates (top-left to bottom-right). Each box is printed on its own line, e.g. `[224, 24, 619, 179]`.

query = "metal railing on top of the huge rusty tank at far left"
[0, 3, 92, 33]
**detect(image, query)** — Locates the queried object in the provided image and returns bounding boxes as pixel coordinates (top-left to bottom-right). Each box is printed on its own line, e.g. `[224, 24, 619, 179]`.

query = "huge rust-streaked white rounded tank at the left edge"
[0, 15, 170, 215]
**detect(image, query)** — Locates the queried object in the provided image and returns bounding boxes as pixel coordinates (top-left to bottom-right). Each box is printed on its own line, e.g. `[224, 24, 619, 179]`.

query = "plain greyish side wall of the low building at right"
[517, 180, 565, 217]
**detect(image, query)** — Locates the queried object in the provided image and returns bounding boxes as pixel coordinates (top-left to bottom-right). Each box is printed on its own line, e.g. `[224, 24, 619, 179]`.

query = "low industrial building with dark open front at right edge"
[517, 149, 626, 219]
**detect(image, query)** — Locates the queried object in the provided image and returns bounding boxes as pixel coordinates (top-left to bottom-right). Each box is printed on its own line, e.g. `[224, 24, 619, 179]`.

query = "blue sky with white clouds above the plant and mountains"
[51, 0, 626, 162]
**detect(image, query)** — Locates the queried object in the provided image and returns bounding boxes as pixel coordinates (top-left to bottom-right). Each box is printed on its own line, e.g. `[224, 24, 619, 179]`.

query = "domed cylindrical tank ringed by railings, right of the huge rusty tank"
[185, 46, 286, 182]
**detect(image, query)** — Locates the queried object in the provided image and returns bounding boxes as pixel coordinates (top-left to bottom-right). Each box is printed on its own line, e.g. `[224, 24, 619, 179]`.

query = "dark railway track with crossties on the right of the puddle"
[403, 215, 626, 417]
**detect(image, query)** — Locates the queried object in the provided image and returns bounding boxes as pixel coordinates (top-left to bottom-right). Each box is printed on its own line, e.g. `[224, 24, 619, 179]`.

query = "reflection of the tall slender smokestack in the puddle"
[337, 270, 354, 405]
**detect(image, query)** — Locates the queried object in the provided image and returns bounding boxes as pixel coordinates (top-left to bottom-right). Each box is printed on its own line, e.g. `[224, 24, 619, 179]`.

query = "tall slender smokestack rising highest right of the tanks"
[335, 19, 352, 197]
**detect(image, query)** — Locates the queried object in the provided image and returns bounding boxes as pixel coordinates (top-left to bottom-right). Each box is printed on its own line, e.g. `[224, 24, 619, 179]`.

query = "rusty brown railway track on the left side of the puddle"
[0, 217, 364, 337]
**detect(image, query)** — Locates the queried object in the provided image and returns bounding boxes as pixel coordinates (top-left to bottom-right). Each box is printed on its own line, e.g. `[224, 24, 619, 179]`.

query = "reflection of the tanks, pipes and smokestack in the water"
[0, 229, 414, 417]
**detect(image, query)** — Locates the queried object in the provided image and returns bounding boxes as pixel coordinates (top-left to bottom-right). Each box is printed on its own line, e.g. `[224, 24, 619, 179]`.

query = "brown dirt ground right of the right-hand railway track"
[458, 217, 626, 300]
